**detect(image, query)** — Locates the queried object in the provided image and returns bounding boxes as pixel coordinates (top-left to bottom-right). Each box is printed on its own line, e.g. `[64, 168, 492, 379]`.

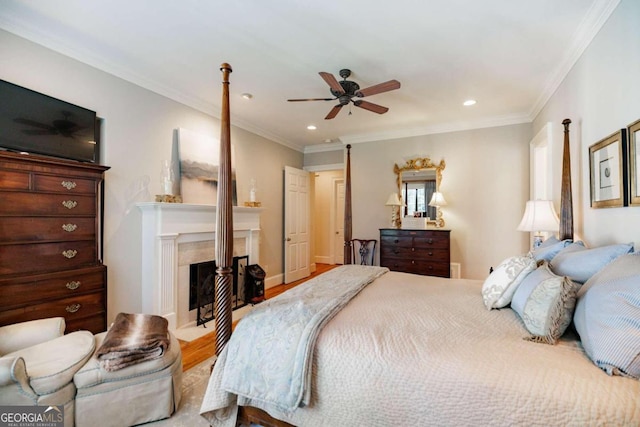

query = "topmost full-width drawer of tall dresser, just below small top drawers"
[0, 191, 96, 216]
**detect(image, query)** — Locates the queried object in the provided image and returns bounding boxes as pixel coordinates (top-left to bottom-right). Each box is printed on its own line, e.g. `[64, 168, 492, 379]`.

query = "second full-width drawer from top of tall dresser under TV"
[0, 217, 96, 243]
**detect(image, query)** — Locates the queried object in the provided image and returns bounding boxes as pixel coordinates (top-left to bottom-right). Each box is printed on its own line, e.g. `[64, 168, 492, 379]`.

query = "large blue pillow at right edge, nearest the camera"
[573, 253, 640, 379]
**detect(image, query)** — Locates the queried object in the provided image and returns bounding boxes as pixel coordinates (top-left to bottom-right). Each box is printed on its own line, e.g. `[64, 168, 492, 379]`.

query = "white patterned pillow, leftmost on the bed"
[482, 254, 537, 310]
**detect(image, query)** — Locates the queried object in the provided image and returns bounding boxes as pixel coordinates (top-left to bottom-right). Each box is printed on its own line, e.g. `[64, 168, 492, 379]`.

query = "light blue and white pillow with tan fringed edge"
[511, 262, 579, 344]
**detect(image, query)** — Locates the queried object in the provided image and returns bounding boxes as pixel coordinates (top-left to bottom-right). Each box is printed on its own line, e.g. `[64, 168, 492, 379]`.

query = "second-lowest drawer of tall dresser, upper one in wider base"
[0, 266, 107, 310]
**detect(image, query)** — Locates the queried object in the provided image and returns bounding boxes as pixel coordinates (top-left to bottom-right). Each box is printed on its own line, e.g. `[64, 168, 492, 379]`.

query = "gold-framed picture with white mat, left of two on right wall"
[589, 129, 627, 208]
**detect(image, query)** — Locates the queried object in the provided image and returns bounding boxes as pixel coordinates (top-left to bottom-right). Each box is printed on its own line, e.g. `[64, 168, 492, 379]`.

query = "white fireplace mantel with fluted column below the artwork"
[136, 202, 262, 329]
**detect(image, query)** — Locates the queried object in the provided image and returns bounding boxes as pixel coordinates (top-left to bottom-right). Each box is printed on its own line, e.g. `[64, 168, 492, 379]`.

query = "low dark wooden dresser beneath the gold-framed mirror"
[380, 228, 451, 277]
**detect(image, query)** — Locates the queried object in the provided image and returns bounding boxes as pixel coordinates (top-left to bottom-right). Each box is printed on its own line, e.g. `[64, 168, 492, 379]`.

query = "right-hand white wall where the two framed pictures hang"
[533, 0, 640, 248]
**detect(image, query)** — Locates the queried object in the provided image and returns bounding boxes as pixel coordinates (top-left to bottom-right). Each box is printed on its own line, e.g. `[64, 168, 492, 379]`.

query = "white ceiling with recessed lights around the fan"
[0, 0, 619, 151]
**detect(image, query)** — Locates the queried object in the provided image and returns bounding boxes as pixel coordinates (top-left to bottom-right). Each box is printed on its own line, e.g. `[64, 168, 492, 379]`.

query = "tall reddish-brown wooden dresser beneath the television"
[0, 152, 109, 333]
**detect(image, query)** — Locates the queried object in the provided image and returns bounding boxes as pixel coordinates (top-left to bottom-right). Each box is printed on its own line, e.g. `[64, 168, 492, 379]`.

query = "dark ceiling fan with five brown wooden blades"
[287, 69, 400, 120]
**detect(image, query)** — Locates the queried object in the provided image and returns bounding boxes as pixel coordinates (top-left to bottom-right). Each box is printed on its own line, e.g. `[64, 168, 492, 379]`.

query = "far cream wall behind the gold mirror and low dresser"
[305, 124, 532, 279]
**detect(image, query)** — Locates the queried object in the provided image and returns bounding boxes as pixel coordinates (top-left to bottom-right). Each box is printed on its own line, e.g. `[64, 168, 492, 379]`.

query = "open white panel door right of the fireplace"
[284, 166, 311, 283]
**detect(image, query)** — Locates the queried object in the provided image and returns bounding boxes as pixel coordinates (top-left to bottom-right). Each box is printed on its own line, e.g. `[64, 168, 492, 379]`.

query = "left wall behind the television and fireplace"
[0, 30, 303, 321]
